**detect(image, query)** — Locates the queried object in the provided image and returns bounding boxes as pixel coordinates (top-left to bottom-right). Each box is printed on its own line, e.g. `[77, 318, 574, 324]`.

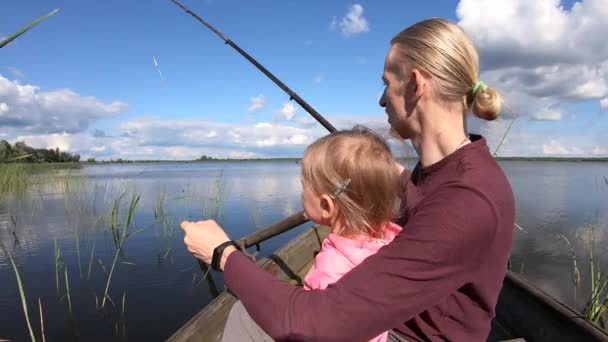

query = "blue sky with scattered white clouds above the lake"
[0, 0, 608, 159]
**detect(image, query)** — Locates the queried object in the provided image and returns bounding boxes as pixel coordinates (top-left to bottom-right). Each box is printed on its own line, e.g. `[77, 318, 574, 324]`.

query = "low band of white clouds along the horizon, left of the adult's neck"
[8, 115, 402, 160]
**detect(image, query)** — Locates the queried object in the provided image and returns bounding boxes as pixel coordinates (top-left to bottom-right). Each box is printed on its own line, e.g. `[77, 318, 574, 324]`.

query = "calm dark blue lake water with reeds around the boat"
[0, 161, 608, 341]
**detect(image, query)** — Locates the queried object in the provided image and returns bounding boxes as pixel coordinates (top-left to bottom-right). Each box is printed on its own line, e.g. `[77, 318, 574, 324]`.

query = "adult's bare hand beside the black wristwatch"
[181, 220, 230, 269]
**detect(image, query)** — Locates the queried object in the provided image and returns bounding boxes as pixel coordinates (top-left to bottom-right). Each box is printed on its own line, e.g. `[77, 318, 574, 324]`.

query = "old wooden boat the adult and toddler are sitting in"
[169, 214, 608, 342]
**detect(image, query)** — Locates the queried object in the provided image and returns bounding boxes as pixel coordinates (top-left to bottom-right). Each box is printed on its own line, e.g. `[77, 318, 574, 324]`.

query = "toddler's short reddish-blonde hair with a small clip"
[302, 126, 400, 238]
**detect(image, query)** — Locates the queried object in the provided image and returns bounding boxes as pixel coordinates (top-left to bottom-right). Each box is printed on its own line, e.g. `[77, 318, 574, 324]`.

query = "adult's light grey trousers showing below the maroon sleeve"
[222, 300, 407, 342]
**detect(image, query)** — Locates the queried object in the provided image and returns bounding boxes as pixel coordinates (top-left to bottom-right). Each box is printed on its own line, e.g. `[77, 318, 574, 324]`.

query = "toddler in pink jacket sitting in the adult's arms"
[302, 126, 401, 342]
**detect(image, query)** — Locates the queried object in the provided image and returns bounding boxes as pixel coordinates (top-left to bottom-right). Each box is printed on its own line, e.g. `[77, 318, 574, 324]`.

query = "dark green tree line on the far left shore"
[0, 140, 80, 163]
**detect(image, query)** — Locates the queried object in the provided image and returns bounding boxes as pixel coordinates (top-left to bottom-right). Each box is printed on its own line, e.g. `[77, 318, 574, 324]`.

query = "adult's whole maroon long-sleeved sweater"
[225, 136, 515, 341]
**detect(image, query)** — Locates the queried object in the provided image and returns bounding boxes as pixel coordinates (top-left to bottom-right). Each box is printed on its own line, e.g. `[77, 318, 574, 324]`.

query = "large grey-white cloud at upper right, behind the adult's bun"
[457, 0, 608, 114]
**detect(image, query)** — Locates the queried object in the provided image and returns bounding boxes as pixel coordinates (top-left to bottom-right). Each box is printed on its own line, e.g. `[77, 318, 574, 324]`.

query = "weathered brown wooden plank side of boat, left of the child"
[168, 226, 330, 342]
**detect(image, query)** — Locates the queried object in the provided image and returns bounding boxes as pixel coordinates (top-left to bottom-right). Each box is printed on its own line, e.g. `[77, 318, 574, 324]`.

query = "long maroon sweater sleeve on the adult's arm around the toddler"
[225, 184, 497, 341]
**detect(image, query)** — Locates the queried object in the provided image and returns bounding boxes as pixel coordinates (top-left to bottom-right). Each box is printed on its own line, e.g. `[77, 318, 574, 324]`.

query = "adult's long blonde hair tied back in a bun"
[391, 18, 502, 120]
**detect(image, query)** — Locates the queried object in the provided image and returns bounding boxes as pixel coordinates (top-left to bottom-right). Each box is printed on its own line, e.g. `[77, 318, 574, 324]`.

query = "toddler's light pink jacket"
[304, 223, 402, 342]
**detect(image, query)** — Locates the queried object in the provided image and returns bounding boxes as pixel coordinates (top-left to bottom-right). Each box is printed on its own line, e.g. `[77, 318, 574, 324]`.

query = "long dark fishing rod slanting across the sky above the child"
[171, 0, 336, 133]
